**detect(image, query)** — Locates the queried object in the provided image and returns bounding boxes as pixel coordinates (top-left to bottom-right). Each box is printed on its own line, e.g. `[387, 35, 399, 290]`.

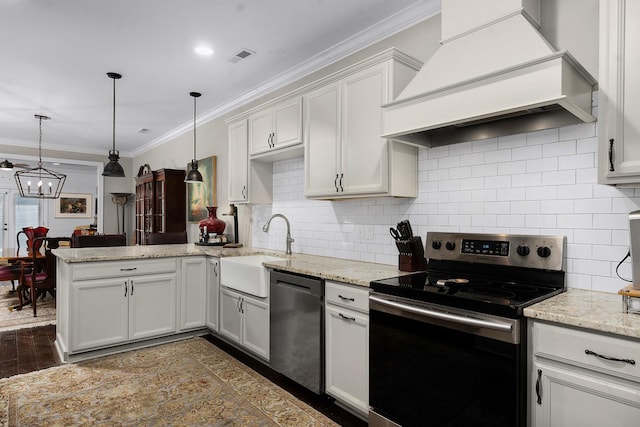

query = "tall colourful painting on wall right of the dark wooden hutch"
[187, 156, 218, 222]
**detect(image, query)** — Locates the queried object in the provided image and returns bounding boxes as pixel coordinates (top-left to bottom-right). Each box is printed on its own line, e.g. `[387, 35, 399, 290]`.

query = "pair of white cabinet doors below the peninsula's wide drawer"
[69, 273, 177, 352]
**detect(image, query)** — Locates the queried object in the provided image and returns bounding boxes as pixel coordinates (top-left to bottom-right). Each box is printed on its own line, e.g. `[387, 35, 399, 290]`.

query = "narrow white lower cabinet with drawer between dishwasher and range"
[325, 281, 369, 416]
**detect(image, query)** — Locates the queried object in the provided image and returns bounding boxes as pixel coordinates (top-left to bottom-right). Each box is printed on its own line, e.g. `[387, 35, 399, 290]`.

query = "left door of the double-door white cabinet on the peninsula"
[69, 278, 129, 352]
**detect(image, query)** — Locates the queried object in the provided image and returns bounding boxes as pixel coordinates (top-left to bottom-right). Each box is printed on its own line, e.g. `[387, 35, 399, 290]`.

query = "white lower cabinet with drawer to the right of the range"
[529, 321, 640, 427]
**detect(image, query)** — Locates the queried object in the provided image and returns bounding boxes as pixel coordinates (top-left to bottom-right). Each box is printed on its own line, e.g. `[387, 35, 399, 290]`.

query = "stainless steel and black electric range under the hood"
[369, 232, 565, 427]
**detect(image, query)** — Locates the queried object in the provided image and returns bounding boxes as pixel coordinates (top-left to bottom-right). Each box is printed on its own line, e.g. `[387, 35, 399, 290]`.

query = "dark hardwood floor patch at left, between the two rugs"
[0, 325, 60, 378]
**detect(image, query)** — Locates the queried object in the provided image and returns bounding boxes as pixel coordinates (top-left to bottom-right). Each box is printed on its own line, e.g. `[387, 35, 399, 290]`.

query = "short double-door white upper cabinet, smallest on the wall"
[249, 96, 302, 158]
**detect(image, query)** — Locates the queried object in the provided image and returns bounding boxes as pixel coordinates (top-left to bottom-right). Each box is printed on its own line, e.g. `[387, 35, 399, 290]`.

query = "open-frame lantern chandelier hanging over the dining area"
[14, 114, 67, 199]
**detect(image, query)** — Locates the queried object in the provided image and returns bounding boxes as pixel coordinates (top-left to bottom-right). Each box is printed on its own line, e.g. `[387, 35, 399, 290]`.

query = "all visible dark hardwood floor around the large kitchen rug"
[0, 325, 367, 427]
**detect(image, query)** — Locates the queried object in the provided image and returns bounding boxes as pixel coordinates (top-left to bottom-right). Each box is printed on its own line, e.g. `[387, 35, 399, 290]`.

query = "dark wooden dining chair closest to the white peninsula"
[16, 237, 71, 317]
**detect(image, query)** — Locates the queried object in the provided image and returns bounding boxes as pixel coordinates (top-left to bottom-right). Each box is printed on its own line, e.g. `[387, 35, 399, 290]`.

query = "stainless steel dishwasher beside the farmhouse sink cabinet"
[269, 271, 324, 394]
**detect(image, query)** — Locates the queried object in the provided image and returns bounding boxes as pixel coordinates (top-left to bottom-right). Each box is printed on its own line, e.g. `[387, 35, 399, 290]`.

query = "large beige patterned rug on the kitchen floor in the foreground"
[0, 338, 337, 427]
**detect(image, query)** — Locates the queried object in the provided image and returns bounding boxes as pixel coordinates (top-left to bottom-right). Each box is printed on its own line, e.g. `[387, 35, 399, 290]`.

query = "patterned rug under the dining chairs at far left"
[0, 282, 56, 332]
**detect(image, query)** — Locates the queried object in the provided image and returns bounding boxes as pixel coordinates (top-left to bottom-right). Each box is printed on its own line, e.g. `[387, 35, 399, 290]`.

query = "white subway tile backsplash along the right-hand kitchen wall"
[251, 123, 640, 292]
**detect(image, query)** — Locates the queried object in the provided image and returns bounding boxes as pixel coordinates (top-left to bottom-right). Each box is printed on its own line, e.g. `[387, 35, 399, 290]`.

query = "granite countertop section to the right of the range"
[524, 288, 640, 338]
